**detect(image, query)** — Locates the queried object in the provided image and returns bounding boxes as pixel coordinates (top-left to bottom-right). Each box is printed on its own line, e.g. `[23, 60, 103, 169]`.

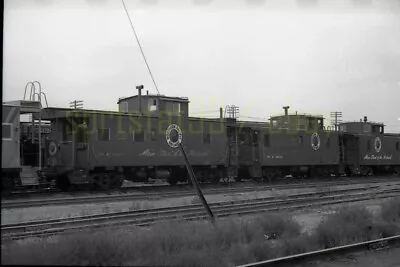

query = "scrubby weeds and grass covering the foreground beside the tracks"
[1, 198, 400, 266]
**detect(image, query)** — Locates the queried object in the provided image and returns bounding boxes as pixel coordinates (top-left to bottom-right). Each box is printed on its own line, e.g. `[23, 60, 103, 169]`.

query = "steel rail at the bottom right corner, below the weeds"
[237, 235, 400, 267]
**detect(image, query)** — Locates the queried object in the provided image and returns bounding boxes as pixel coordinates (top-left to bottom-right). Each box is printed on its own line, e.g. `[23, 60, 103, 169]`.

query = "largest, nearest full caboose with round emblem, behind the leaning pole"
[42, 90, 231, 188]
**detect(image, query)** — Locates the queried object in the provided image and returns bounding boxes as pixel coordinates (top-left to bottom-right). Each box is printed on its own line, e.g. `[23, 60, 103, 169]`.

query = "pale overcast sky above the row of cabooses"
[3, 0, 400, 132]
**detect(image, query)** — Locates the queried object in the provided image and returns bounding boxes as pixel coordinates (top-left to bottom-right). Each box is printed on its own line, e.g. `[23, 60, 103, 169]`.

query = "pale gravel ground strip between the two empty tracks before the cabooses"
[1, 179, 400, 225]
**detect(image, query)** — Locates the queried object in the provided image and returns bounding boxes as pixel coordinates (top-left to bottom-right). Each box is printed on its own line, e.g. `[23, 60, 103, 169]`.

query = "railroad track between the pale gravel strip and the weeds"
[1, 188, 400, 239]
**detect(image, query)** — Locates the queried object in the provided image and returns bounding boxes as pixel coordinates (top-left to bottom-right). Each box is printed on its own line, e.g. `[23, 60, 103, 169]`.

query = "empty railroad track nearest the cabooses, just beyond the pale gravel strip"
[1, 179, 400, 209]
